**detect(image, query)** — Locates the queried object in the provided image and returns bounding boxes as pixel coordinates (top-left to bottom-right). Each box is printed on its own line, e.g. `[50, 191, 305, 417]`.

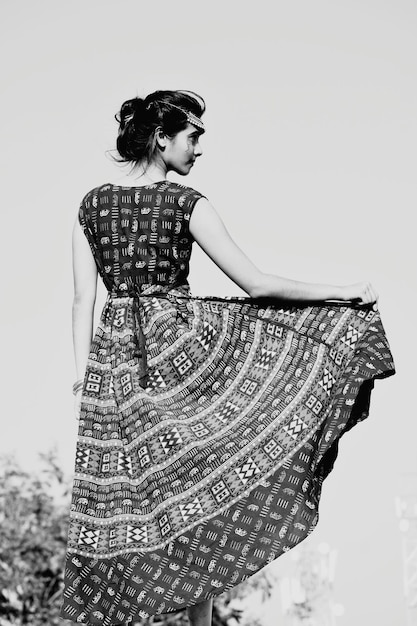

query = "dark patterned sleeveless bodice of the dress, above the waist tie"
[79, 180, 203, 295]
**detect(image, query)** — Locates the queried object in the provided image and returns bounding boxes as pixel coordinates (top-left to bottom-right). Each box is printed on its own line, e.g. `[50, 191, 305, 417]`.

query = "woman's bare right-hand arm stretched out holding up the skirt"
[190, 198, 378, 304]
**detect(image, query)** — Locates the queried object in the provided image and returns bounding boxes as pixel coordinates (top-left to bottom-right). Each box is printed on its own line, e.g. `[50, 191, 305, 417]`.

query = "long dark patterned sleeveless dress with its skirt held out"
[61, 181, 394, 626]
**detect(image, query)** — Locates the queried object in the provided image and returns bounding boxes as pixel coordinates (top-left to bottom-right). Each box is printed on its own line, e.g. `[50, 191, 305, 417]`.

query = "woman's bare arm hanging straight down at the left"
[72, 216, 97, 380]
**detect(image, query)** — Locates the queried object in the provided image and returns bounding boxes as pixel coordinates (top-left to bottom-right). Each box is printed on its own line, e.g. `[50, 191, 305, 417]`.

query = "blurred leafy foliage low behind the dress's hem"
[0, 451, 274, 626]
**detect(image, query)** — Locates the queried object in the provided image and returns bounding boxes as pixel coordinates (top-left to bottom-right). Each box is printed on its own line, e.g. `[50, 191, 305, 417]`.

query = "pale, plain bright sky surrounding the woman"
[0, 0, 417, 626]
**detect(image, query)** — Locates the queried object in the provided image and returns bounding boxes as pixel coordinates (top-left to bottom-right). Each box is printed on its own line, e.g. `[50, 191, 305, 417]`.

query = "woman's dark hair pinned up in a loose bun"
[115, 91, 206, 164]
